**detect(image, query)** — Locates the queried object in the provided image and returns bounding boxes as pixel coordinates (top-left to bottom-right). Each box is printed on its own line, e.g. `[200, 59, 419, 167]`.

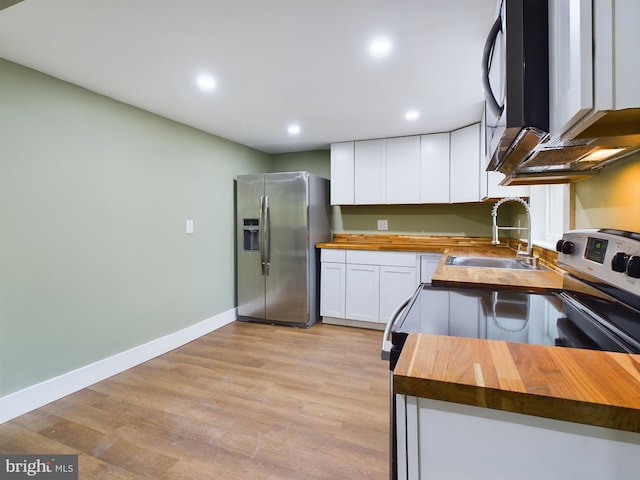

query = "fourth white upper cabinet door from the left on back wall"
[420, 133, 450, 203]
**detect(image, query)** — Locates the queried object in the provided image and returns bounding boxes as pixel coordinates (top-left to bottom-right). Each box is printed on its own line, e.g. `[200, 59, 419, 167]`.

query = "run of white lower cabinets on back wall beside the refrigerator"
[320, 249, 419, 329]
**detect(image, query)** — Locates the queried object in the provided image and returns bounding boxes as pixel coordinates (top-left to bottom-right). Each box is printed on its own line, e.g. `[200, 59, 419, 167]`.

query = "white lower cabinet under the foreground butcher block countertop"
[396, 395, 640, 480]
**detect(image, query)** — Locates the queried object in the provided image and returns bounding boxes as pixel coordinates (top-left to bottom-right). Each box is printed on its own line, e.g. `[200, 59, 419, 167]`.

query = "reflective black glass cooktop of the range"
[392, 284, 640, 353]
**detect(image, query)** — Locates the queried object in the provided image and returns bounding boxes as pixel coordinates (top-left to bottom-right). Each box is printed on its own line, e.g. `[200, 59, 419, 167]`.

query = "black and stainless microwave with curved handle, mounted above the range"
[482, 0, 549, 170]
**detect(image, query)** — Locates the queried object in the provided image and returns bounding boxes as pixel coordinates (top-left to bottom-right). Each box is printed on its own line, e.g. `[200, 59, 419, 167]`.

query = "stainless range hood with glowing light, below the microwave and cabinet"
[487, 108, 640, 185]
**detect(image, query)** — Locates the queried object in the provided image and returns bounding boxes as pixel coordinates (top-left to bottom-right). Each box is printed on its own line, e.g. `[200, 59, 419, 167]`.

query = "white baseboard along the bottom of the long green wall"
[0, 308, 237, 423]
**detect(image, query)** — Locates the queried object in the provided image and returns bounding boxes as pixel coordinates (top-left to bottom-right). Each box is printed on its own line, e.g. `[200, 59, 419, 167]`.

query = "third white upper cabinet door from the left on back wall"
[386, 137, 420, 204]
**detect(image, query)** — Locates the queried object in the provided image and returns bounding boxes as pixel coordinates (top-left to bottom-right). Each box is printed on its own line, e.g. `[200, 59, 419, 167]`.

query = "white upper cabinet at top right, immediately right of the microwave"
[549, 0, 640, 140]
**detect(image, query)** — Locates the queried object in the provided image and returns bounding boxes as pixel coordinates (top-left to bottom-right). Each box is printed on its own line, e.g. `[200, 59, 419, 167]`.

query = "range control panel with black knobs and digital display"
[556, 228, 640, 295]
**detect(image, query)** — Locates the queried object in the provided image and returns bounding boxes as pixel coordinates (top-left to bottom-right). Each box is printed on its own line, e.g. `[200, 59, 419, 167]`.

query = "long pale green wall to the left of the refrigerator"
[0, 60, 272, 396]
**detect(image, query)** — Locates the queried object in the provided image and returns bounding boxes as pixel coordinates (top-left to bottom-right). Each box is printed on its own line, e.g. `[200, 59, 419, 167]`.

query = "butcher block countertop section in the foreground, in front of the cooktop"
[393, 333, 640, 432]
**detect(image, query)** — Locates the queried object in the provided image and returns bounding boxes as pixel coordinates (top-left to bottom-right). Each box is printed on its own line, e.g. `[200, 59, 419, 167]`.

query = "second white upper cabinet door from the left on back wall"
[354, 139, 386, 205]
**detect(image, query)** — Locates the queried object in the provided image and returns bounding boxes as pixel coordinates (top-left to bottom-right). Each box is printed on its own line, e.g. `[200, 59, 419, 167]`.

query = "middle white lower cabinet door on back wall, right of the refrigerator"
[346, 264, 380, 322]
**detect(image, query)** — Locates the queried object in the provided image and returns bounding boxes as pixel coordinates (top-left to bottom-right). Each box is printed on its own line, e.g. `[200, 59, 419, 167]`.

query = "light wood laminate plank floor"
[0, 322, 389, 480]
